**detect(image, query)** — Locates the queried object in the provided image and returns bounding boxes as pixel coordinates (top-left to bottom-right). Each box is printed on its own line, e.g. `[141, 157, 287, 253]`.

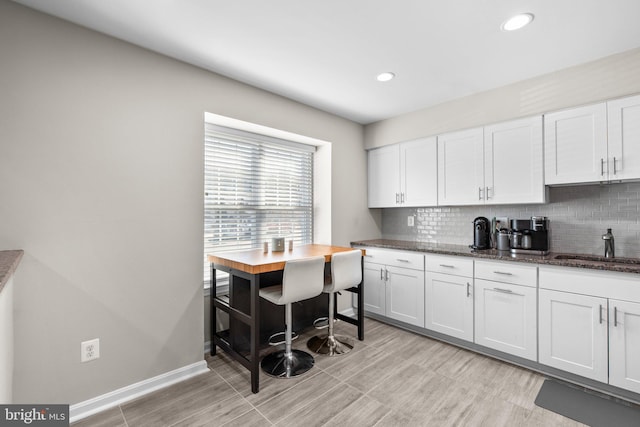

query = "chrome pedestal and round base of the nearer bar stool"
[260, 304, 315, 378]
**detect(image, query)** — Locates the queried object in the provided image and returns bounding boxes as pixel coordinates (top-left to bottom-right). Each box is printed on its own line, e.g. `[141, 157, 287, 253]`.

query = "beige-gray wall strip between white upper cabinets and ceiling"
[365, 48, 640, 149]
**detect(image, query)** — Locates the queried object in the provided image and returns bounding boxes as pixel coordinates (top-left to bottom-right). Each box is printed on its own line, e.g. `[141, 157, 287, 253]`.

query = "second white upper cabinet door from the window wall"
[400, 137, 438, 206]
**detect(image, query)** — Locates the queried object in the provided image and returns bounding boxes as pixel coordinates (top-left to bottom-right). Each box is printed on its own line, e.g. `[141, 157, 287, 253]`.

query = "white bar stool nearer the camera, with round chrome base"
[260, 256, 324, 378]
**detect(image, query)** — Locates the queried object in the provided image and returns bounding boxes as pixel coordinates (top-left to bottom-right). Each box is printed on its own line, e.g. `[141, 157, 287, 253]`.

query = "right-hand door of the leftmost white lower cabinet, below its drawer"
[384, 266, 424, 328]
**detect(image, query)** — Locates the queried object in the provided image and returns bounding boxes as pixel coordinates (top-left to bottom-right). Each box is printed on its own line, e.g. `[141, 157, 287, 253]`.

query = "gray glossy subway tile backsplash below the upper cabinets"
[382, 182, 640, 257]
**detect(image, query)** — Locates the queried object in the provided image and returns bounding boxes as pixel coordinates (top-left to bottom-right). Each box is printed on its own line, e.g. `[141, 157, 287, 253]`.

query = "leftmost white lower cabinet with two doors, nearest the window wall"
[364, 248, 424, 327]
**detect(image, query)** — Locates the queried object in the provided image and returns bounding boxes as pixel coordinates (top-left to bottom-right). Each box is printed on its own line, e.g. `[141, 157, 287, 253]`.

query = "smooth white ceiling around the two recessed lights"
[14, 0, 640, 124]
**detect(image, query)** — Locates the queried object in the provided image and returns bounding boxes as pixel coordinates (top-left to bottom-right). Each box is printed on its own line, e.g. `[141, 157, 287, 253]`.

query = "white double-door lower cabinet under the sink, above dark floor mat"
[538, 267, 640, 393]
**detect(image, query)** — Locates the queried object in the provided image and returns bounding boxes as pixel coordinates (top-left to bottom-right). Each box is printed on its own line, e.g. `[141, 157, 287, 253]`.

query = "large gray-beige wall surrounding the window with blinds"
[0, 0, 380, 403]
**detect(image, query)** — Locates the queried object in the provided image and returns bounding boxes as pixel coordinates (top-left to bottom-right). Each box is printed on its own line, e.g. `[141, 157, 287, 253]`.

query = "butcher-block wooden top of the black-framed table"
[207, 244, 364, 274]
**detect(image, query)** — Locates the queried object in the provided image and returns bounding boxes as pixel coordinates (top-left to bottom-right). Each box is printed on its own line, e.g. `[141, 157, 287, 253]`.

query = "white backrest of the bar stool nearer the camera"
[281, 256, 324, 304]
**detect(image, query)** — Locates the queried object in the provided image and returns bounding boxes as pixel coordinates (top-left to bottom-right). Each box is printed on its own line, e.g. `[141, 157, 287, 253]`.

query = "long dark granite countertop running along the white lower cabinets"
[351, 239, 640, 274]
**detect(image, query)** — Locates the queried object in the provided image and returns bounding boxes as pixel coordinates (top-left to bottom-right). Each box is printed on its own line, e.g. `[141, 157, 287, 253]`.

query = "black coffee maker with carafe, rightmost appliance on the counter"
[510, 216, 551, 255]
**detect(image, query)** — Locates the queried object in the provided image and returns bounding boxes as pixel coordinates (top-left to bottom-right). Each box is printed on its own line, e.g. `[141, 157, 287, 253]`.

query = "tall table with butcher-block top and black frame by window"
[208, 245, 364, 393]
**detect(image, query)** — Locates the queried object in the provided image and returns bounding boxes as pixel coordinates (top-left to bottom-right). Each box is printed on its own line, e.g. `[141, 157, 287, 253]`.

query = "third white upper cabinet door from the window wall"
[438, 128, 485, 205]
